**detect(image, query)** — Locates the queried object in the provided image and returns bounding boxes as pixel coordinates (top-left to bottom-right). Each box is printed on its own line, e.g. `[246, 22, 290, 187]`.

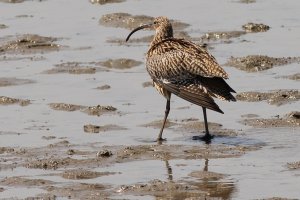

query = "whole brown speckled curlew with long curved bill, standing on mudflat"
[126, 17, 236, 142]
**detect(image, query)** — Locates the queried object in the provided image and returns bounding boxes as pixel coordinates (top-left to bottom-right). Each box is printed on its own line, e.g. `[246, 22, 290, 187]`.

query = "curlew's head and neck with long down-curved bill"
[126, 17, 173, 42]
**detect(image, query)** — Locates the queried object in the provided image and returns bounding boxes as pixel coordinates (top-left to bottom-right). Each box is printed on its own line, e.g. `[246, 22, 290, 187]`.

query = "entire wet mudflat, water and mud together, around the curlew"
[0, 0, 300, 199]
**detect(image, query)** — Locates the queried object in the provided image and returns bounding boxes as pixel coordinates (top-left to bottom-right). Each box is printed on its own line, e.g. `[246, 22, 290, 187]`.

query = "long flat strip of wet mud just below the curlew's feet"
[0, 141, 261, 172]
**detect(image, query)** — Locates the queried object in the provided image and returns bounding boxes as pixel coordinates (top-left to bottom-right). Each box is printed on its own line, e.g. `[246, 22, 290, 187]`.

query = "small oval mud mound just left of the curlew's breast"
[99, 58, 143, 69]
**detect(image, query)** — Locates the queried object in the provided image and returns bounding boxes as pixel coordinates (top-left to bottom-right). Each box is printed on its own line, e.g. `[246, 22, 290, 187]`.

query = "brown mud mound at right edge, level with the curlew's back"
[226, 55, 300, 72]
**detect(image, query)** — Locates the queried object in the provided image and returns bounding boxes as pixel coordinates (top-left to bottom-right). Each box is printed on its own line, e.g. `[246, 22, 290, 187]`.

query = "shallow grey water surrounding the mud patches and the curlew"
[0, 0, 300, 199]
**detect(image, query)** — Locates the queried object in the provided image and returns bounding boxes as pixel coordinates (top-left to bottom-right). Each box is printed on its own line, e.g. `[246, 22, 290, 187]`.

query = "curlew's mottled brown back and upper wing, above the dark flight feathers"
[147, 38, 228, 79]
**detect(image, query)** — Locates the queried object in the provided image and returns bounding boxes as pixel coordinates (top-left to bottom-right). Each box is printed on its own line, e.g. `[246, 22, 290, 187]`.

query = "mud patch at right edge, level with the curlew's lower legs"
[241, 111, 300, 128]
